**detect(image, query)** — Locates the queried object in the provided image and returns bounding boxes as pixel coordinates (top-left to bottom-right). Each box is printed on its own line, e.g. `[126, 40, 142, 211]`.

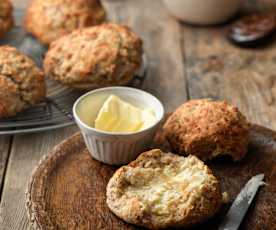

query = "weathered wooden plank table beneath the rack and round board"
[0, 0, 276, 230]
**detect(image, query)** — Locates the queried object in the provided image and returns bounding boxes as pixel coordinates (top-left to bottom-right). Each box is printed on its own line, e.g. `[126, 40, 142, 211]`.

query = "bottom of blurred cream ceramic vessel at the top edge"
[163, 0, 241, 25]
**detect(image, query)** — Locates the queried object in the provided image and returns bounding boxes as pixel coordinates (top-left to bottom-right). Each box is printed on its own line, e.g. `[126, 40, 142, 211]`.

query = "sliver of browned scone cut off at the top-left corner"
[0, 0, 14, 37]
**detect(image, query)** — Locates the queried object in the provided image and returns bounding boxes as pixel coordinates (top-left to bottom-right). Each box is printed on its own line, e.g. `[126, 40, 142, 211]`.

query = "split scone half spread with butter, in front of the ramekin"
[107, 149, 222, 229]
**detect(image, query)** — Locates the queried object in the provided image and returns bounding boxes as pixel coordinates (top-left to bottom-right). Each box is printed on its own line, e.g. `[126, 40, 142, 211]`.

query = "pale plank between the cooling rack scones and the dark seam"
[104, 0, 187, 111]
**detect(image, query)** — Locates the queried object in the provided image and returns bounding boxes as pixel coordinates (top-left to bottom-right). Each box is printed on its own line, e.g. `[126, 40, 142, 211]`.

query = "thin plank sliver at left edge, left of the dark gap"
[0, 137, 12, 200]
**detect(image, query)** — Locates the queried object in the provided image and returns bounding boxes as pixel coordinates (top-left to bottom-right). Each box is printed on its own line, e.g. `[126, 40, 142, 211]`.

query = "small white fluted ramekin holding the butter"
[73, 87, 164, 165]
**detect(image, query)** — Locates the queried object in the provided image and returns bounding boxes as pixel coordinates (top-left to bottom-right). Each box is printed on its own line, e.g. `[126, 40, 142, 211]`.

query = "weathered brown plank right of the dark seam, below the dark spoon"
[182, 1, 276, 129]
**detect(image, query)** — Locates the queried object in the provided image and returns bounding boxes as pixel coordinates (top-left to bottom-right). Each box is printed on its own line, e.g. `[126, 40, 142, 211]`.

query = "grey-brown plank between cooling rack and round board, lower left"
[0, 126, 77, 230]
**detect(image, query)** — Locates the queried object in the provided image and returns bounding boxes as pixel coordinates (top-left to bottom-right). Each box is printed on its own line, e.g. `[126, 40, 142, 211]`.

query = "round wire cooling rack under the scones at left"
[0, 10, 147, 135]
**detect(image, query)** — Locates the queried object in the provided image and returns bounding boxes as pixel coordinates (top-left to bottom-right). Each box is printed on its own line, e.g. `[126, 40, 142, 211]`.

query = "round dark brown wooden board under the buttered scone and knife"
[26, 125, 276, 230]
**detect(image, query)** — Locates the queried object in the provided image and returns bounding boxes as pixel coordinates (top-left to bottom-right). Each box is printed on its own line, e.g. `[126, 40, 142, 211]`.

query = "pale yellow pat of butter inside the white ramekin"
[95, 95, 156, 132]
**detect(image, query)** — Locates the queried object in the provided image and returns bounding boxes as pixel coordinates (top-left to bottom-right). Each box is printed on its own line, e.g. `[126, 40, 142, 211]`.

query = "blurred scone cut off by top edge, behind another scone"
[24, 0, 106, 44]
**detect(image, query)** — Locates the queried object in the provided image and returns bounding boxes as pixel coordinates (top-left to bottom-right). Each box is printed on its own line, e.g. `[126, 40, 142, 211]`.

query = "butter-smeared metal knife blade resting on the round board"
[219, 174, 264, 230]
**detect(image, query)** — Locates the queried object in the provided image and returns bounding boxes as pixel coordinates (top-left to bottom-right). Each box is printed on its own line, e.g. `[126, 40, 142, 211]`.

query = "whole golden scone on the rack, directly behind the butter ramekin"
[44, 23, 143, 89]
